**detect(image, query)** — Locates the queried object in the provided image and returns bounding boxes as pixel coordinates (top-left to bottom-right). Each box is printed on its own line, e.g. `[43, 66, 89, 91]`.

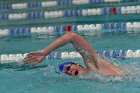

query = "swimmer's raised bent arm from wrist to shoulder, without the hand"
[42, 32, 100, 69]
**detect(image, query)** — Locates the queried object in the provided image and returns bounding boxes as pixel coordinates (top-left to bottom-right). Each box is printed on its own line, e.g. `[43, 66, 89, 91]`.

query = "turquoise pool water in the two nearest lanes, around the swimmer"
[0, 34, 140, 93]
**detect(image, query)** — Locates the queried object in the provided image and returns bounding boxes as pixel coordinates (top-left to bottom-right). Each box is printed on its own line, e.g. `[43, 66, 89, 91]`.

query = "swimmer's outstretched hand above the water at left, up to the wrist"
[23, 50, 46, 65]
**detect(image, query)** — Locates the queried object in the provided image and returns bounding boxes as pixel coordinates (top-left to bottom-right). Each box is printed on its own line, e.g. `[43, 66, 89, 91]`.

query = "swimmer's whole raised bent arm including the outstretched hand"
[23, 32, 100, 70]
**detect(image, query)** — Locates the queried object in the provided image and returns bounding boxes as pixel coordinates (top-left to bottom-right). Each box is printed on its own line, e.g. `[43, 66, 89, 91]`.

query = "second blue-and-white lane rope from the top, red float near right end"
[0, 5, 140, 20]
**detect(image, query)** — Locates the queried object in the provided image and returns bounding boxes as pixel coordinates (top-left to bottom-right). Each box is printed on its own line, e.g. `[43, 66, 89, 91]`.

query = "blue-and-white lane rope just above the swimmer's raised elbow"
[0, 22, 140, 37]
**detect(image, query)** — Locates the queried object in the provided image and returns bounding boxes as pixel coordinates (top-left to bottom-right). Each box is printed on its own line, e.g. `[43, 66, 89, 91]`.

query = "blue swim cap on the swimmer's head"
[54, 61, 74, 74]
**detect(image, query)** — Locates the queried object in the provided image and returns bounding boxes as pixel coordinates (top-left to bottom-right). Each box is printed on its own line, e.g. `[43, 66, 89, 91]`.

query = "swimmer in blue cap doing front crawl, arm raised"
[23, 27, 124, 76]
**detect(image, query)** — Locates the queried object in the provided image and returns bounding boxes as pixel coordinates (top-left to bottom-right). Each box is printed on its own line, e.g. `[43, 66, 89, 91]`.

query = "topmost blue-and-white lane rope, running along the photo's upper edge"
[0, 0, 138, 10]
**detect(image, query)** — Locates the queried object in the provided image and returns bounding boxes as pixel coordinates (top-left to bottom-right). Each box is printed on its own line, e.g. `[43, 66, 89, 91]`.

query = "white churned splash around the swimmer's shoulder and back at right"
[79, 60, 140, 83]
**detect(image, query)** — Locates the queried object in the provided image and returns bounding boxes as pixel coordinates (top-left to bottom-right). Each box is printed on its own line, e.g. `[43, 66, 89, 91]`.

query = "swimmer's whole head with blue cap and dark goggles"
[58, 61, 84, 76]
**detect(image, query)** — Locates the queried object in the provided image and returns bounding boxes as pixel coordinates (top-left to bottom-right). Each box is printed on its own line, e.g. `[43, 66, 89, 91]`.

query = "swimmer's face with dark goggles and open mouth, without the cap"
[63, 64, 84, 76]
